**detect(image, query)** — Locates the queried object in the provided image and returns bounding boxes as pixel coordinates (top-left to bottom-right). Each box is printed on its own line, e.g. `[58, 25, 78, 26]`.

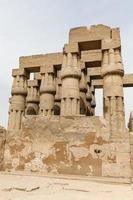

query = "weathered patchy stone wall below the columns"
[4, 116, 131, 177]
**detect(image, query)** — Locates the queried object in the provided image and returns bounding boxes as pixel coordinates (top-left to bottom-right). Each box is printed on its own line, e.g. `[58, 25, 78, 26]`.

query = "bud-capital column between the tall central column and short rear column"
[39, 66, 56, 116]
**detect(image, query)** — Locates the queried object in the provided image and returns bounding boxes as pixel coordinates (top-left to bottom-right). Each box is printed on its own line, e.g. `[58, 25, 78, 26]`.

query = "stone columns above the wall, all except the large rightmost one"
[8, 45, 95, 132]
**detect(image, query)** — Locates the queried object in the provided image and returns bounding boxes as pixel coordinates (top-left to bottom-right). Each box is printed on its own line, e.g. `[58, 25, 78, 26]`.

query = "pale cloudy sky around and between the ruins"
[0, 0, 133, 126]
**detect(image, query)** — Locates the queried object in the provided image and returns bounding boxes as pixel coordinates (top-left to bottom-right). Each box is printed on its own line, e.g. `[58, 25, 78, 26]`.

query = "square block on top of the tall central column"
[63, 42, 79, 53]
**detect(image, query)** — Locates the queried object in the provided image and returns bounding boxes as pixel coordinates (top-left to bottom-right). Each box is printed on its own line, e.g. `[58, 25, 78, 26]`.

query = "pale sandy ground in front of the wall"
[0, 174, 133, 200]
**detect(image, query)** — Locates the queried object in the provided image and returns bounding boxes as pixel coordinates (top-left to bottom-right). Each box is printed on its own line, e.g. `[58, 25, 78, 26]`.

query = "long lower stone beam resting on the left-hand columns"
[19, 52, 63, 72]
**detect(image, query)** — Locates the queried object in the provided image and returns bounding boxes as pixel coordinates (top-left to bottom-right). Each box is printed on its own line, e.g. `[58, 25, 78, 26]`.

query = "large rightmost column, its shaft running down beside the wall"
[101, 48, 125, 139]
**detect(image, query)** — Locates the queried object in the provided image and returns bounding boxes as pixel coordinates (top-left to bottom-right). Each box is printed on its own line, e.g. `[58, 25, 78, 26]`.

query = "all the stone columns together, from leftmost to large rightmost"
[8, 45, 125, 141]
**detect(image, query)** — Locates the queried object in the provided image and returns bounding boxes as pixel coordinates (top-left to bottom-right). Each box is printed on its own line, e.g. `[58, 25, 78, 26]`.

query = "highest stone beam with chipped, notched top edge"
[69, 24, 120, 43]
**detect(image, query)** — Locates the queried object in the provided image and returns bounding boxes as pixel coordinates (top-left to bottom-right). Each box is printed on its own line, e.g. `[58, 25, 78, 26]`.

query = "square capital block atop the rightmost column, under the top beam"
[102, 39, 121, 50]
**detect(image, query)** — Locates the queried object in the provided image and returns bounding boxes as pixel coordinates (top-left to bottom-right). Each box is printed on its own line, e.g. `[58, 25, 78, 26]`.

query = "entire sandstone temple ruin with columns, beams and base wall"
[2, 25, 133, 179]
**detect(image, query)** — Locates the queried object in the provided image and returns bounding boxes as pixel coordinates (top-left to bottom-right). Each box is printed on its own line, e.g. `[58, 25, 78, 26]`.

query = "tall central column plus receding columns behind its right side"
[61, 44, 96, 116]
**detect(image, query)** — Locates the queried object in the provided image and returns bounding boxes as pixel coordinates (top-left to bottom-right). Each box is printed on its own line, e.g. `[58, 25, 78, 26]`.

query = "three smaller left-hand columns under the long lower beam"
[8, 68, 55, 130]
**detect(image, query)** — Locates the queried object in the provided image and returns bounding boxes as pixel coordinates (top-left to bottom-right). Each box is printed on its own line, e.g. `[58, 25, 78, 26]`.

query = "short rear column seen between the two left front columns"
[26, 80, 39, 115]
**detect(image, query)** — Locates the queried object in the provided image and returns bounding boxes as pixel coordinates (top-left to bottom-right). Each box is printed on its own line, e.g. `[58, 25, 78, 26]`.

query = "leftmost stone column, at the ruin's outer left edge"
[8, 69, 27, 130]
